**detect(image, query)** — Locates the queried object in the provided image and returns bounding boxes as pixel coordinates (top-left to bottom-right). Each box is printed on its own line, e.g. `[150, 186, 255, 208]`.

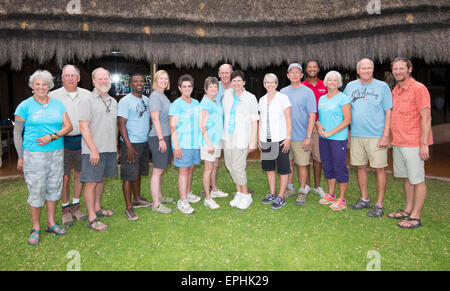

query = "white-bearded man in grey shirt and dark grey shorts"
[79, 67, 118, 231]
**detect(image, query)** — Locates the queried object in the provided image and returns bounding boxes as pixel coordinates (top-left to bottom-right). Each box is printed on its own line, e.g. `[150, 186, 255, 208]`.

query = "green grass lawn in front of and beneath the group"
[0, 162, 450, 271]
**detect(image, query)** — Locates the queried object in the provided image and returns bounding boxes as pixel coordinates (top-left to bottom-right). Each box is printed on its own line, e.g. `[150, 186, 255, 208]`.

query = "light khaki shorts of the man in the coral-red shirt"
[392, 146, 425, 185]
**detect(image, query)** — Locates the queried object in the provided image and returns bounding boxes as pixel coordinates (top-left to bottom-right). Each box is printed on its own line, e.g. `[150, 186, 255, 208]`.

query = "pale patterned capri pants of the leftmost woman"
[23, 149, 64, 208]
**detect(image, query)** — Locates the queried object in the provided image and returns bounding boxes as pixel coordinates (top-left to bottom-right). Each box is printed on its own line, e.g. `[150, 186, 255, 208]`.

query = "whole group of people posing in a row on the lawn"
[14, 58, 432, 245]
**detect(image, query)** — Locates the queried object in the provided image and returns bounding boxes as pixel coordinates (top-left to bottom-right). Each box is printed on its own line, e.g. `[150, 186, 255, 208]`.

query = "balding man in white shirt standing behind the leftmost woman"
[49, 64, 90, 226]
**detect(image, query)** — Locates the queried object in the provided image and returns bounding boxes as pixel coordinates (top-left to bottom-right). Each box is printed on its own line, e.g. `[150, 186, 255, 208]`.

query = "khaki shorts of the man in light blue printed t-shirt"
[350, 136, 388, 169]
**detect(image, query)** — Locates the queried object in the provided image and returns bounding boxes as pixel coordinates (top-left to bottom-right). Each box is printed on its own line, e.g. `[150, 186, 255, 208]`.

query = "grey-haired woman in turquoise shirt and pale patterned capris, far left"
[14, 70, 72, 245]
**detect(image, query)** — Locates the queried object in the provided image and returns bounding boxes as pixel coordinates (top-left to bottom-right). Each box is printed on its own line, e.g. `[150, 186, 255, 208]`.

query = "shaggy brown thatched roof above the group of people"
[0, 0, 450, 69]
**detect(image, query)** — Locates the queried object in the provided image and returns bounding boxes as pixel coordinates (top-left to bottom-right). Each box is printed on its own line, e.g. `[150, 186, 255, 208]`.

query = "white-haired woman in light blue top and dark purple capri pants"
[316, 71, 352, 210]
